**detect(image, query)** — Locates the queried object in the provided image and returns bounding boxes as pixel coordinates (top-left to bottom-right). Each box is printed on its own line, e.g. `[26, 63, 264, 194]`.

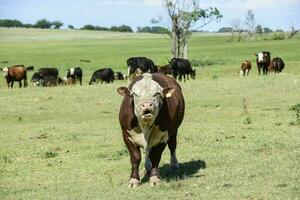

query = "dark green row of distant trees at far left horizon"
[0, 19, 63, 29]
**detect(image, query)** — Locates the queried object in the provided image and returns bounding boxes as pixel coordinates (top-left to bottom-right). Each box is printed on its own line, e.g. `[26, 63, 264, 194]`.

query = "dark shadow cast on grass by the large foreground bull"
[142, 160, 206, 182]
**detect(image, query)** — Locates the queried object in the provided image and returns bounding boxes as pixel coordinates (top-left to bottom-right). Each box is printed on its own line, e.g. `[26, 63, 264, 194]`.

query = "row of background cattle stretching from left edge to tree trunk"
[0, 57, 196, 88]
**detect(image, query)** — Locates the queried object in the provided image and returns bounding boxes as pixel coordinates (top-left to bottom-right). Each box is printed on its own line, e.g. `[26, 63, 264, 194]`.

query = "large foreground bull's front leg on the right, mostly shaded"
[149, 143, 166, 186]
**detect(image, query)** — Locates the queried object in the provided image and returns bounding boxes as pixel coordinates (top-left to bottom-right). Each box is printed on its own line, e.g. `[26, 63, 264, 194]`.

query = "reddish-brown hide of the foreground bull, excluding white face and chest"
[118, 73, 185, 187]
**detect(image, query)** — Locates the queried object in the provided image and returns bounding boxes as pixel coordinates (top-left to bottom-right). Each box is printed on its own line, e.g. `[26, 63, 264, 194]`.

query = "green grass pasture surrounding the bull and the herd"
[0, 29, 300, 199]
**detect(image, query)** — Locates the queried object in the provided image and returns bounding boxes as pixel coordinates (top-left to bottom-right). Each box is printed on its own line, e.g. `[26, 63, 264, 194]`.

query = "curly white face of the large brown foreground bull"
[131, 74, 163, 125]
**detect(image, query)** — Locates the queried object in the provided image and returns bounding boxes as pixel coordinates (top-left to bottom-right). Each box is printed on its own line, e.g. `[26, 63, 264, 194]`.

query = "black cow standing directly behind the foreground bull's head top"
[127, 57, 158, 78]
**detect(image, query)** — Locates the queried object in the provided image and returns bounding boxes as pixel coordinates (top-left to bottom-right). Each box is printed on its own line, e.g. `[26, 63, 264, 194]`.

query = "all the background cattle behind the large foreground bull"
[0, 51, 285, 88]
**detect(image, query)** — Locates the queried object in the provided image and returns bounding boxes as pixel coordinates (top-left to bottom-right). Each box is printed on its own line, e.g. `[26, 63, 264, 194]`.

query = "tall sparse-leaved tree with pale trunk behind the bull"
[165, 0, 222, 58]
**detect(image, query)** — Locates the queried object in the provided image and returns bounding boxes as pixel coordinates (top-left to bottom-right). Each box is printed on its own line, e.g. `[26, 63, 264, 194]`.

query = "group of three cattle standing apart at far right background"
[240, 51, 285, 76]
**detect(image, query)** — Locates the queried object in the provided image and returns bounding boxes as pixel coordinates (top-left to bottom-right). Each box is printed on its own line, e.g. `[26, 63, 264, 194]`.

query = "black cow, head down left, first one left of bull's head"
[89, 68, 114, 85]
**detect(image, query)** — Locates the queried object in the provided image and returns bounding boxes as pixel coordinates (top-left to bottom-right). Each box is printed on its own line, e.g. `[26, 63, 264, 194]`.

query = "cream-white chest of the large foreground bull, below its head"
[128, 126, 169, 150]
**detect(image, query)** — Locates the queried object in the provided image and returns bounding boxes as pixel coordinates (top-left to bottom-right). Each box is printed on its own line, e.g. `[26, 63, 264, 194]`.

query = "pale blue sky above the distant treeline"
[0, 0, 300, 31]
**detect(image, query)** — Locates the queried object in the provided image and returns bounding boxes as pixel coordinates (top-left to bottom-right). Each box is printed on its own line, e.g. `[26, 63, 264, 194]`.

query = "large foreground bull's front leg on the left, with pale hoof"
[123, 130, 141, 188]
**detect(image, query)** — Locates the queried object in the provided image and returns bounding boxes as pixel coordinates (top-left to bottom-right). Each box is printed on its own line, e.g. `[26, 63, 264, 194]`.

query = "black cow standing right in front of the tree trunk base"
[169, 58, 196, 81]
